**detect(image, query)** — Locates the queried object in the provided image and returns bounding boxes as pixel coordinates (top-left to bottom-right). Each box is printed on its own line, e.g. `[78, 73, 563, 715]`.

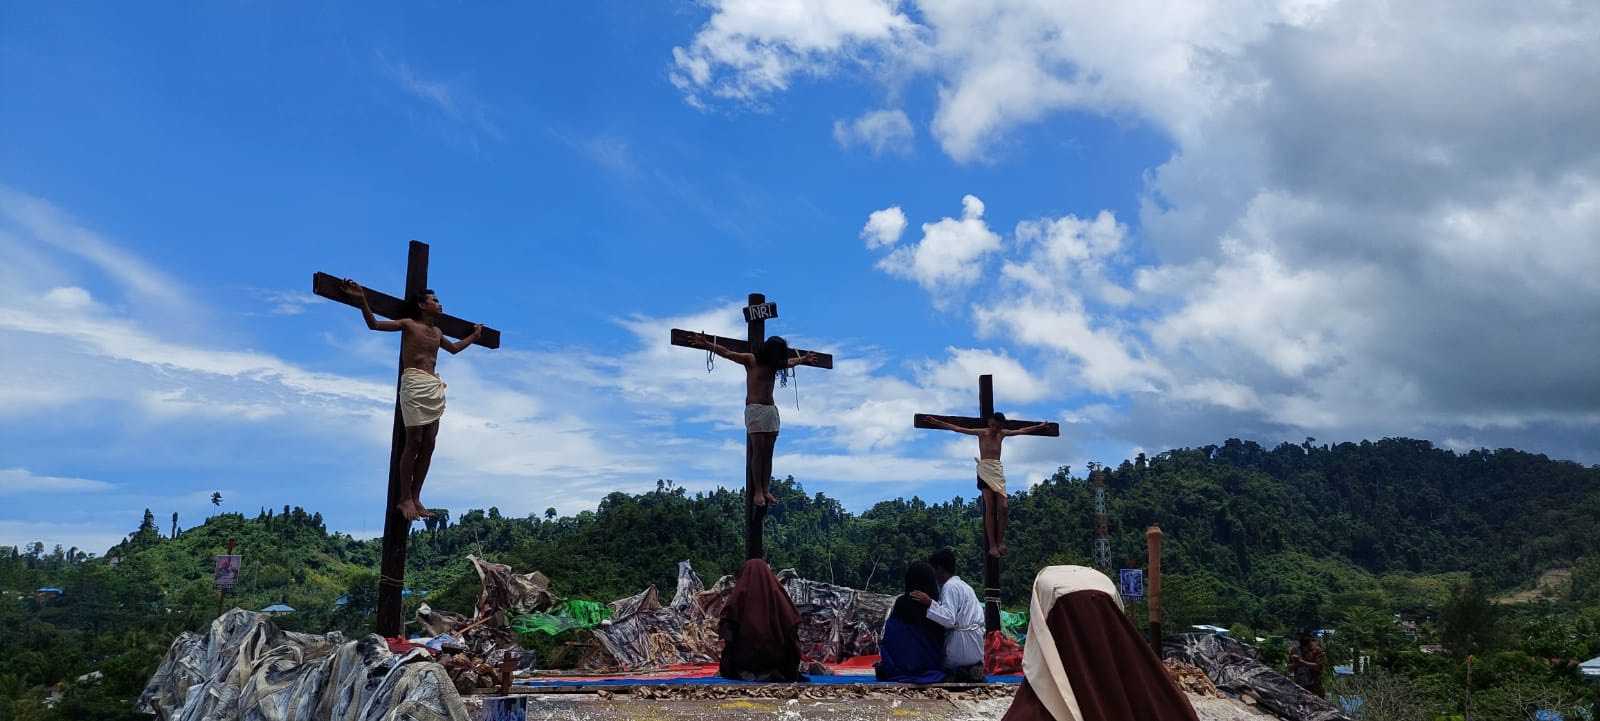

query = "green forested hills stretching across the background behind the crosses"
[0, 440, 1600, 718]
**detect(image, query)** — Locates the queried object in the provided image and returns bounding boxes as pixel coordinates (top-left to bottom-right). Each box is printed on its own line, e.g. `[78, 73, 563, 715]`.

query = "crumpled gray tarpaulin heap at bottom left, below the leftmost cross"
[139, 609, 467, 721]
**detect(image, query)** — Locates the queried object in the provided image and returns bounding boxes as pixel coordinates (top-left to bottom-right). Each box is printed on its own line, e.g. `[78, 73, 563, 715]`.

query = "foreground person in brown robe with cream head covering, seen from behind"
[1002, 566, 1198, 721]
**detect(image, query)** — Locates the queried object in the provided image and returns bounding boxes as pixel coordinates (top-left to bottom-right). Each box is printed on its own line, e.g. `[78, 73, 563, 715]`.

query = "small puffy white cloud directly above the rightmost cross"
[878, 195, 1000, 295]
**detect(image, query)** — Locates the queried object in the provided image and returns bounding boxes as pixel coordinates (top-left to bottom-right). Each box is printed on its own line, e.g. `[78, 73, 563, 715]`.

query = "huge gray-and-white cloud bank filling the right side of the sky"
[784, 0, 1600, 459]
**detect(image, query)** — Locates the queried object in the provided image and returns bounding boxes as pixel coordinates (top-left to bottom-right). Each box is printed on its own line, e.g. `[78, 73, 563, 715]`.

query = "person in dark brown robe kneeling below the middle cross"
[717, 558, 803, 681]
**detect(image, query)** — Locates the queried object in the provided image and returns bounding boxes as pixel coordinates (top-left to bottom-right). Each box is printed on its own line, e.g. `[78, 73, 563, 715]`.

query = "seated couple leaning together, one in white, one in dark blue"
[875, 548, 984, 684]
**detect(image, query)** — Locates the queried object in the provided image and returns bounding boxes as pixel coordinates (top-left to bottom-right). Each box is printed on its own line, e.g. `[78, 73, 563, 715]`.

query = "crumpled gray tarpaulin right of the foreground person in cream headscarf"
[1162, 633, 1350, 721]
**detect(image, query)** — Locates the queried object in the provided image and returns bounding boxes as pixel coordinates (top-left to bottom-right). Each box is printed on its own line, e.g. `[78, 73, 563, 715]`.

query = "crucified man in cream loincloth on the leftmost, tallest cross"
[344, 278, 483, 521]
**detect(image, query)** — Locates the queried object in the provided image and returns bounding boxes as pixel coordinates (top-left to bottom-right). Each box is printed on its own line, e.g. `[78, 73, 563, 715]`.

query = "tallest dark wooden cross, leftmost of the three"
[310, 240, 499, 636]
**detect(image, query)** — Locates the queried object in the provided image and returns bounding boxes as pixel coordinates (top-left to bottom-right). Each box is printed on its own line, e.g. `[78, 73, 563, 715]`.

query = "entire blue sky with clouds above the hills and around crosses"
[0, 0, 1600, 552]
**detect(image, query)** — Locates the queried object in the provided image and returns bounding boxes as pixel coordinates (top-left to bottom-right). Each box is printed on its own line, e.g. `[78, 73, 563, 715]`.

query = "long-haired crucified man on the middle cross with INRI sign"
[693, 333, 816, 510]
